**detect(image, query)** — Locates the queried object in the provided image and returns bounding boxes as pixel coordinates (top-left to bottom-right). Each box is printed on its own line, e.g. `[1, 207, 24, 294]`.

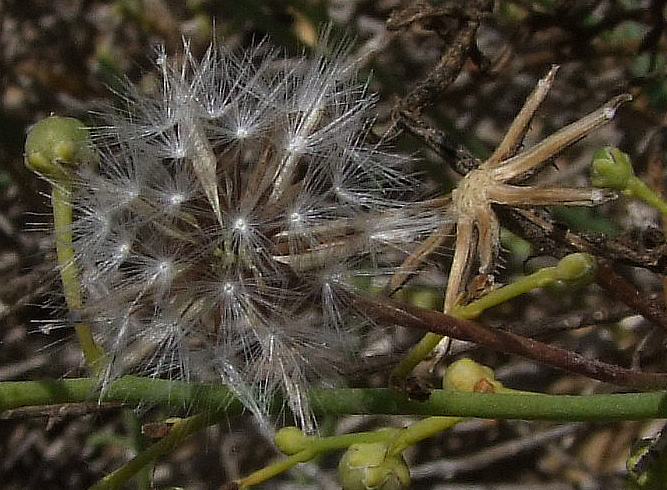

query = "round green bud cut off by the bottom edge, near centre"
[338, 442, 410, 490]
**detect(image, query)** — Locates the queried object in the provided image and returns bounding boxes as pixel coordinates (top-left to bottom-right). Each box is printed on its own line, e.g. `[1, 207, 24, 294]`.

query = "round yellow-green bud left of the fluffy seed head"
[25, 116, 94, 181]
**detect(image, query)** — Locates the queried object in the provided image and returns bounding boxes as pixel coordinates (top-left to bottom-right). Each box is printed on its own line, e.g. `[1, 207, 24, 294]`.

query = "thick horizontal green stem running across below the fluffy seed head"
[0, 376, 667, 422]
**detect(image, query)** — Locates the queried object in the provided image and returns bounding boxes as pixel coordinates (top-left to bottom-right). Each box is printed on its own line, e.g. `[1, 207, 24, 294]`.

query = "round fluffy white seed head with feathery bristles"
[54, 36, 440, 430]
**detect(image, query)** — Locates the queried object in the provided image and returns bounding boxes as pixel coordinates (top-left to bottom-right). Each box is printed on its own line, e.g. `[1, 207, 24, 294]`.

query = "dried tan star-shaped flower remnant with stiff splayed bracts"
[388, 66, 632, 312]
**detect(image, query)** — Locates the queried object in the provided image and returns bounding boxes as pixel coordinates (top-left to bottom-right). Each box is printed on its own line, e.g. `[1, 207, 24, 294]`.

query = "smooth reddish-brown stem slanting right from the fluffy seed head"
[352, 295, 667, 389]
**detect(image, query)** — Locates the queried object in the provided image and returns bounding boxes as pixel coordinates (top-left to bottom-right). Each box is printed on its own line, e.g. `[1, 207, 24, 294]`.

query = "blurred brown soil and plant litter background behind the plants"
[0, 0, 667, 490]
